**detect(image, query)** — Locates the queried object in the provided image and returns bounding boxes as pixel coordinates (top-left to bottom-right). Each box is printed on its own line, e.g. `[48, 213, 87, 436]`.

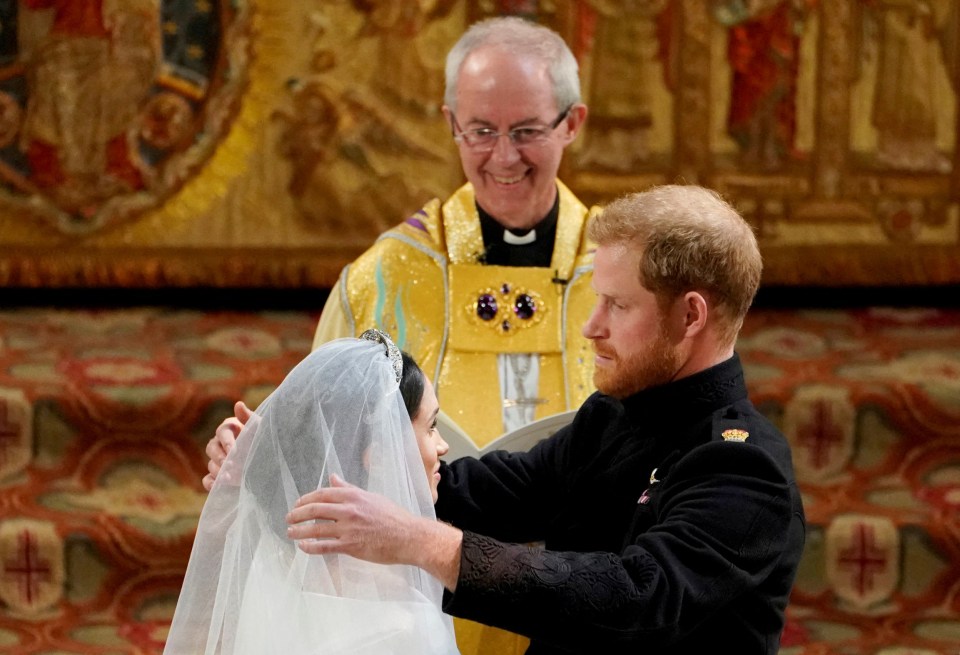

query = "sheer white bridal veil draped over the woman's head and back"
[164, 339, 457, 655]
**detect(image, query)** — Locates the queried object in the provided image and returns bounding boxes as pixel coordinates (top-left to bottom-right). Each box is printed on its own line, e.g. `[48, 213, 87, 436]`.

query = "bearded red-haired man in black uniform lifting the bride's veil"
[287, 186, 805, 655]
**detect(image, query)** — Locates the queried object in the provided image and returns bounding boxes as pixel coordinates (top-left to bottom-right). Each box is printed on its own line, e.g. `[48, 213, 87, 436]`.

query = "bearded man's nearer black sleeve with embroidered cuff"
[444, 442, 791, 652]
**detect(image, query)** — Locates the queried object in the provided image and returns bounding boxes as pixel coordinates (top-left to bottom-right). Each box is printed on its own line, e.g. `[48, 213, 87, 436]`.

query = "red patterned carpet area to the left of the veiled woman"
[0, 309, 316, 654]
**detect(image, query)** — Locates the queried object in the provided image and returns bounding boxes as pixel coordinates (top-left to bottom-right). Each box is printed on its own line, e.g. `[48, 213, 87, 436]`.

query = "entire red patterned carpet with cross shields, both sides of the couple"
[0, 309, 960, 655]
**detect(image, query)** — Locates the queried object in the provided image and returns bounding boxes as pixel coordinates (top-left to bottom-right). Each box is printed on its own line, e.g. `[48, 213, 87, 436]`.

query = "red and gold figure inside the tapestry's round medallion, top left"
[21, 0, 161, 213]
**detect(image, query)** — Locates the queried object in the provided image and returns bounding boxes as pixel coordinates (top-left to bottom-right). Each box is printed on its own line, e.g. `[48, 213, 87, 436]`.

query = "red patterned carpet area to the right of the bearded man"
[738, 309, 960, 655]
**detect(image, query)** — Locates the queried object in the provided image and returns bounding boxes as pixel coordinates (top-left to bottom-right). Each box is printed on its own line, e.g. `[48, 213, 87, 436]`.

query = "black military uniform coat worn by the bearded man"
[437, 355, 804, 655]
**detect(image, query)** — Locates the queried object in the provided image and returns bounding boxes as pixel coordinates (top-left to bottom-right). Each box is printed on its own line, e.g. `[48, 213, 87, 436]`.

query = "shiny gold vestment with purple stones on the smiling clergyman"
[336, 181, 594, 447]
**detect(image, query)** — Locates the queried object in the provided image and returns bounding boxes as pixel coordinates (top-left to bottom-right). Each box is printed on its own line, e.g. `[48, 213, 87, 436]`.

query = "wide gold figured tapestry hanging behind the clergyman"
[0, 0, 960, 287]
